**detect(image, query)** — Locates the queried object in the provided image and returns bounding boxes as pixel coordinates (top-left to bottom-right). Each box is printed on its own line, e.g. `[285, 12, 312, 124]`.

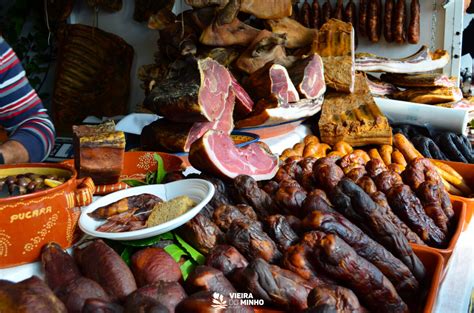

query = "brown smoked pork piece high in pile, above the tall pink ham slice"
[199, 18, 260, 47]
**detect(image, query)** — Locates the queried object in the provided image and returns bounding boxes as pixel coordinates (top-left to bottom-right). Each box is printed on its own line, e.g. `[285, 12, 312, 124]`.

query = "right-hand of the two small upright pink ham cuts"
[288, 53, 326, 99]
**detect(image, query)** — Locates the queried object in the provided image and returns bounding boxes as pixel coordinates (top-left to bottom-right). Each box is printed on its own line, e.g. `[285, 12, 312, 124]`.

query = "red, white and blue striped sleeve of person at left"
[0, 36, 55, 162]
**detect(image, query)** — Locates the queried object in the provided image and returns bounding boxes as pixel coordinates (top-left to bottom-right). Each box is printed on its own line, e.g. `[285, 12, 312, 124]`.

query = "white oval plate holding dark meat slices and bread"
[79, 179, 214, 240]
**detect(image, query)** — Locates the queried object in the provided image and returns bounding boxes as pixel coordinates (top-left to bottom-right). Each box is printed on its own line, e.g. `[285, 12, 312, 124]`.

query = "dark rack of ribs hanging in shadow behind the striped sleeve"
[52, 24, 133, 132]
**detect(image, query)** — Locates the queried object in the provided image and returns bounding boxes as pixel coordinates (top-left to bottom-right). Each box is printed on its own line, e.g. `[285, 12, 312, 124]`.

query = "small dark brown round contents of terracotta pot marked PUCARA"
[0, 173, 66, 197]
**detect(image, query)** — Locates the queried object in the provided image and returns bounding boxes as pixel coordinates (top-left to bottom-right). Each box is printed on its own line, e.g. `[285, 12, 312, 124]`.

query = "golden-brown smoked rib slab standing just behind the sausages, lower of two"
[319, 74, 392, 146]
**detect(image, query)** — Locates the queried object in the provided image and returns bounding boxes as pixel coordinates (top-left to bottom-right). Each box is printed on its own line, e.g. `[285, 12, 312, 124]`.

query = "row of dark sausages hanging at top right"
[293, 0, 420, 44]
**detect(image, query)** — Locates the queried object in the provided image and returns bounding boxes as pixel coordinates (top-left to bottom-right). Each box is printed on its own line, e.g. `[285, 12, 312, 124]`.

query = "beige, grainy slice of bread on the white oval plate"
[146, 196, 196, 227]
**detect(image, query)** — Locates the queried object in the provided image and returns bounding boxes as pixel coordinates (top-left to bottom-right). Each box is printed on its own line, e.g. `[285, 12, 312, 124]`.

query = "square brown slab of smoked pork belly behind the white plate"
[73, 121, 125, 185]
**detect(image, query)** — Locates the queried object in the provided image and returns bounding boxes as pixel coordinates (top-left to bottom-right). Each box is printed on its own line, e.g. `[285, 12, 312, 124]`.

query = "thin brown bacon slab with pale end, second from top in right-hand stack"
[380, 73, 456, 88]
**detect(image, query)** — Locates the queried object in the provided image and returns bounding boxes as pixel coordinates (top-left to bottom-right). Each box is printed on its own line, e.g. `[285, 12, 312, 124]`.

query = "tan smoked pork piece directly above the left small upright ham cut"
[235, 29, 287, 74]
